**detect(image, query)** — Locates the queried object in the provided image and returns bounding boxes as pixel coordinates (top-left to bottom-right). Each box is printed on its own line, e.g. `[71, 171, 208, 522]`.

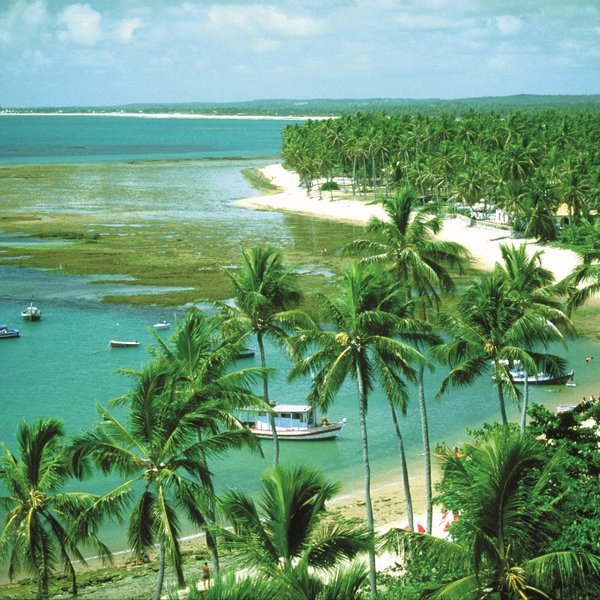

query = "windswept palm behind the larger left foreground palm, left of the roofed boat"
[149, 309, 268, 575]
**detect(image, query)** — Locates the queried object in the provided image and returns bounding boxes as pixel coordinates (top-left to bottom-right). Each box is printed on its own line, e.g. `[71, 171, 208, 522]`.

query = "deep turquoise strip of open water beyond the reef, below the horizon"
[0, 115, 294, 164]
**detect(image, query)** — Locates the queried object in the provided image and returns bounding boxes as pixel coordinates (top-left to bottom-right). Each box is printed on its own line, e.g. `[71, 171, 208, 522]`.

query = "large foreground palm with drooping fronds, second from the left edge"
[73, 360, 253, 600]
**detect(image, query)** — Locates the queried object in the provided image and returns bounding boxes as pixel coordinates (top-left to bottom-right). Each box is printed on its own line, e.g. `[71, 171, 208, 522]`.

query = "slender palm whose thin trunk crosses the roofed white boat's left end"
[218, 246, 310, 465]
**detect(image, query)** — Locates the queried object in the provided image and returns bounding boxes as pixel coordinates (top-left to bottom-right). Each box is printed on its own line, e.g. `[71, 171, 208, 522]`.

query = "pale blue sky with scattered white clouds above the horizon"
[0, 0, 600, 107]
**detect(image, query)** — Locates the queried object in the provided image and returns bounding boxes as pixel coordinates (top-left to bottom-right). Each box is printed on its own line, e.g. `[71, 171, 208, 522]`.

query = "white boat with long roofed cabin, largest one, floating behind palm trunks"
[238, 404, 346, 442]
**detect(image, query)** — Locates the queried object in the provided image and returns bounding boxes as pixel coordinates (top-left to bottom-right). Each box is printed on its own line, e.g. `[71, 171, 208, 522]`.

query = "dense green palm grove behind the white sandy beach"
[282, 109, 600, 243]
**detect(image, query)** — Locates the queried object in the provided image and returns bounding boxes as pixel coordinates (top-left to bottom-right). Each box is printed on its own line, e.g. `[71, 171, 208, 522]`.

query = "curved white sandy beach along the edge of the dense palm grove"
[237, 164, 578, 281]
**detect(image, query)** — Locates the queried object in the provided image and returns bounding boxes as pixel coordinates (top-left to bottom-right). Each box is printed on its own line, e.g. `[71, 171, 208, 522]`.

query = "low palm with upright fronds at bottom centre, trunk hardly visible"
[221, 465, 371, 598]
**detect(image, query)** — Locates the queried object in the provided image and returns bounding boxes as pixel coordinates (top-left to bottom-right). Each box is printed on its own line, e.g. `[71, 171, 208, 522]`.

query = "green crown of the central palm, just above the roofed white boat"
[289, 264, 434, 409]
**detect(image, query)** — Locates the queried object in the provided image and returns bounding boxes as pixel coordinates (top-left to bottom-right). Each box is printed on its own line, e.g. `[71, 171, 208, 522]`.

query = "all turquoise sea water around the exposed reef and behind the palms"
[0, 116, 600, 549]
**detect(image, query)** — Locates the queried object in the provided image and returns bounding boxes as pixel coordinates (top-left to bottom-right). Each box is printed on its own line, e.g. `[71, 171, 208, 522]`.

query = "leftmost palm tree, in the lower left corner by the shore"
[0, 418, 110, 598]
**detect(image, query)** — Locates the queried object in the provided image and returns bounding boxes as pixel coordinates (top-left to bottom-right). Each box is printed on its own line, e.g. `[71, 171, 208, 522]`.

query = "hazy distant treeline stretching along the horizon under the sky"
[0, 94, 600, 117]
